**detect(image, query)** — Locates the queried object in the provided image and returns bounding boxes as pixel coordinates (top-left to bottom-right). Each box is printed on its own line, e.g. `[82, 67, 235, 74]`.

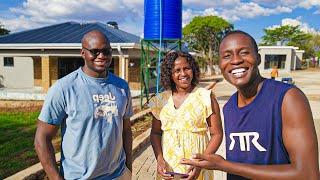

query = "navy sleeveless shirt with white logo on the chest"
[223, 79, 293, 179]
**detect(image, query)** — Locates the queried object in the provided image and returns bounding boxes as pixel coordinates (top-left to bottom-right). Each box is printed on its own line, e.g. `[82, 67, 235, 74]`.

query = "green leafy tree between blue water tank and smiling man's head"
[183, 16, 233, 74]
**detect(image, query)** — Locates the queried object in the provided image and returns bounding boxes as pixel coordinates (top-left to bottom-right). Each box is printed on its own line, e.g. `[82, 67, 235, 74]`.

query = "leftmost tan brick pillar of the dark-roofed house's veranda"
[41, 56, 51, 92]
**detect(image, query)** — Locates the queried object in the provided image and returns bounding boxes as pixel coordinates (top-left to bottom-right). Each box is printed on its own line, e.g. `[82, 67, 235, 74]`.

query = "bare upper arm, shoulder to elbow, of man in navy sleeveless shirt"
[281, 88, 320, 179]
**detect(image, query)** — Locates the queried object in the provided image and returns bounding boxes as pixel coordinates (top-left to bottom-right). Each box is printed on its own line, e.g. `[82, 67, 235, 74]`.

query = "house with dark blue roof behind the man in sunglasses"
[0, 22, 140, 92]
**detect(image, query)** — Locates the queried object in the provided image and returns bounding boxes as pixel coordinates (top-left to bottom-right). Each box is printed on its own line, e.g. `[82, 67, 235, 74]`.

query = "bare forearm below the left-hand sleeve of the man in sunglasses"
[34, 120, 63, 179]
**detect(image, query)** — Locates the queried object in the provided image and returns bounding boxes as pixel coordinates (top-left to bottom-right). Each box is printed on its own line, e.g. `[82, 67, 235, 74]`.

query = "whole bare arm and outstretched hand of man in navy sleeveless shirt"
[182, 88, 320, 180]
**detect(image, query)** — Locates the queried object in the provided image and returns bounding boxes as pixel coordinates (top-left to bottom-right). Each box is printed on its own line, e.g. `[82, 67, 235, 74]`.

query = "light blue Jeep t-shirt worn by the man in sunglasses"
[39, 68, 132, 179]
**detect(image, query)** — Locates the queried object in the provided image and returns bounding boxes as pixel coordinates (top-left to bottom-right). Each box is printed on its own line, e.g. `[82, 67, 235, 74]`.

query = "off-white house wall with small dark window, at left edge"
[0, 57, 34, 88]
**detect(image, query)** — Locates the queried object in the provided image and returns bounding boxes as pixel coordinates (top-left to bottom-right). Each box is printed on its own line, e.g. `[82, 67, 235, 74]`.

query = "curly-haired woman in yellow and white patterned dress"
[149, 52, 223, 180]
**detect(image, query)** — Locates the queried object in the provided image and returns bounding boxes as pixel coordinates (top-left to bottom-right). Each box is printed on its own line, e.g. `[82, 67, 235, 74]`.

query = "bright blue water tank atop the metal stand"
[144, 0, 182, 40]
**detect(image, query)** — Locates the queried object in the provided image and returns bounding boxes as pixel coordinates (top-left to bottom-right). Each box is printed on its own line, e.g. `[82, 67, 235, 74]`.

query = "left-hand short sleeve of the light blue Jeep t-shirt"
[38, 81, 66, 125]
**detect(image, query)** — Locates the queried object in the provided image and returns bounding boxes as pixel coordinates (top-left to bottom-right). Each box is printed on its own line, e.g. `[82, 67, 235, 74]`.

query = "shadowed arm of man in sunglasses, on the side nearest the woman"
[122, 118, 132, 172]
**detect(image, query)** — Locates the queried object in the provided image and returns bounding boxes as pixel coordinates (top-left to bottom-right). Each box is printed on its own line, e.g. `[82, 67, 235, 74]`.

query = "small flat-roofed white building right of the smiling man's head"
[259, 46, 304, 72]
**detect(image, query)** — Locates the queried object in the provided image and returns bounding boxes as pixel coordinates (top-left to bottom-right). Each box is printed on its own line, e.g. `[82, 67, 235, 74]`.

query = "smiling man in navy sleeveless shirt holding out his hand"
[182, 31, 320, 180]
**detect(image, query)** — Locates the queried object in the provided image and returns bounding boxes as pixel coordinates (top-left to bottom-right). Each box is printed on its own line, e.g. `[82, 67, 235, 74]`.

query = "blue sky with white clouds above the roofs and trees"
[0, 0, 320, 42]
